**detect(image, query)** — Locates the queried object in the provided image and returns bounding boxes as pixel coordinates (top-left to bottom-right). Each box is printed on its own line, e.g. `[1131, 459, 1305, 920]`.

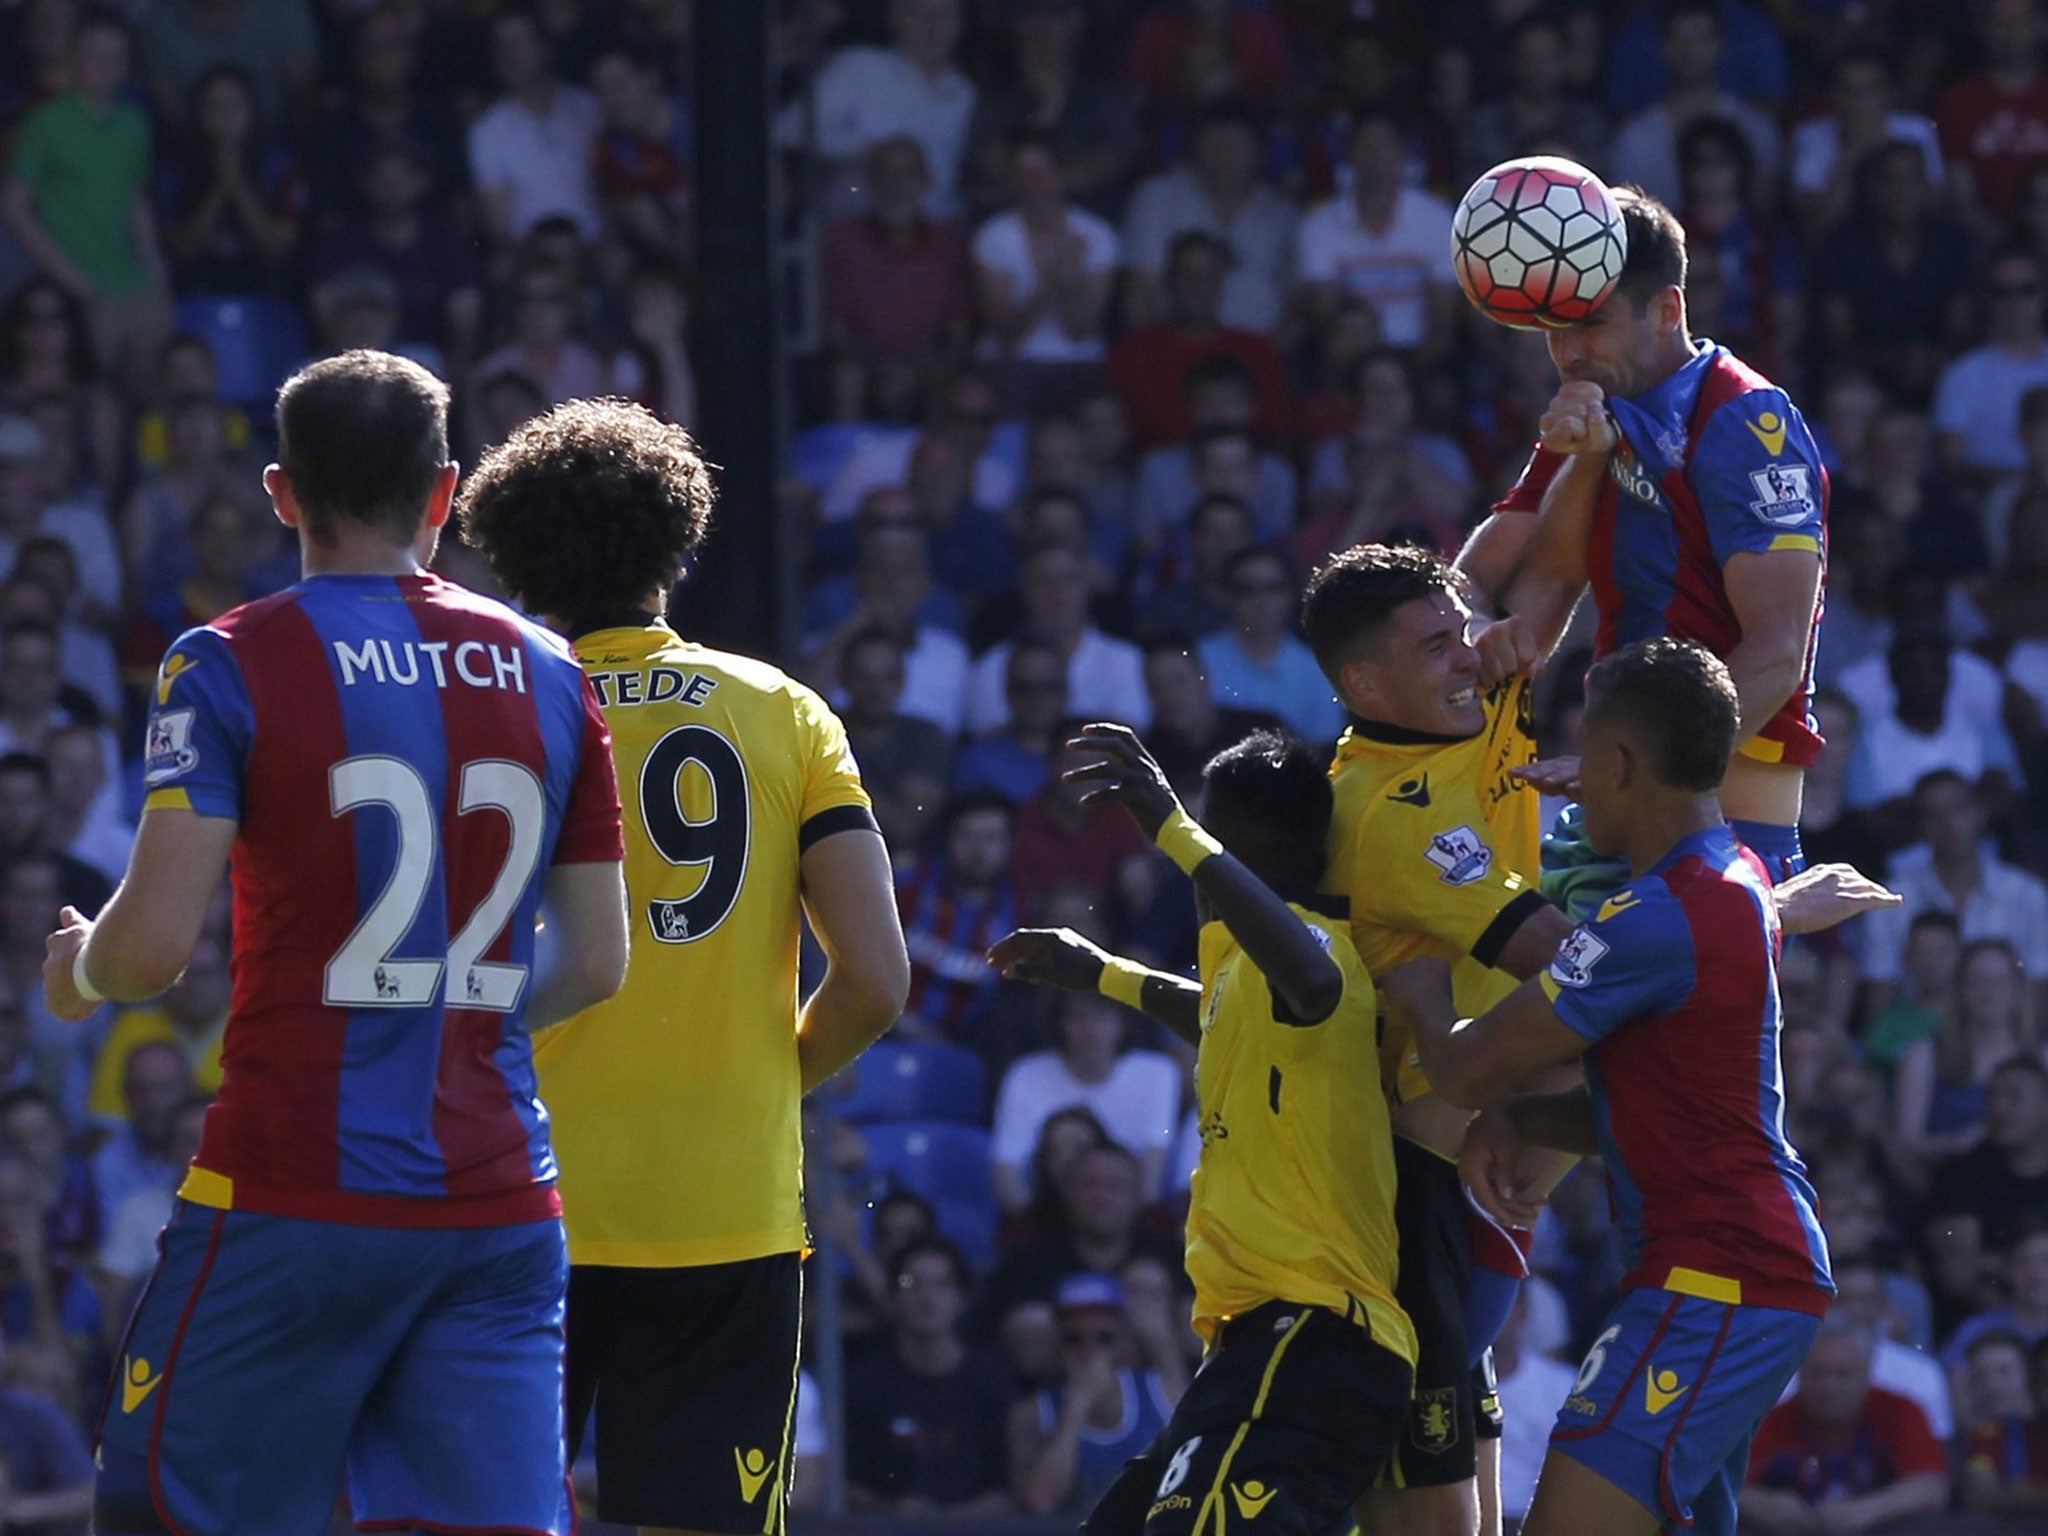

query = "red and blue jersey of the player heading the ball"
[1493, 340, 1829, 766]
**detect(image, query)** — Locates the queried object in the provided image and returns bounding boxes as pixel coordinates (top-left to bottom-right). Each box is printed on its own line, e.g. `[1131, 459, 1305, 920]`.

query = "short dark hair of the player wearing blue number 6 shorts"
[1585, 637, 1741, 795]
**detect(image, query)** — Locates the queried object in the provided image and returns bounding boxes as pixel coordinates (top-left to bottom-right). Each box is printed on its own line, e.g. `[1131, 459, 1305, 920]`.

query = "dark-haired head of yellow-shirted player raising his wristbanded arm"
[1202, 731, 1335, 893]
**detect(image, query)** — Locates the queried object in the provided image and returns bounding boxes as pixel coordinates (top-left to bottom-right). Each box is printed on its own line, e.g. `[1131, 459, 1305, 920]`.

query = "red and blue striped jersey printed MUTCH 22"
[145, 575, 625, 1227]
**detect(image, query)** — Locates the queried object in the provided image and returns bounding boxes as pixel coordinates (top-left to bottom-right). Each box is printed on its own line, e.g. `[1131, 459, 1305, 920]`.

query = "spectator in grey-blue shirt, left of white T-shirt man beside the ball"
[1122, 102, 1300, 336]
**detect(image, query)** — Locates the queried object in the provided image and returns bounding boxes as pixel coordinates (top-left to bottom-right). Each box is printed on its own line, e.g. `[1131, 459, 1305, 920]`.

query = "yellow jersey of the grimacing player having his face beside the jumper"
[1323, 678, 1542, 1100]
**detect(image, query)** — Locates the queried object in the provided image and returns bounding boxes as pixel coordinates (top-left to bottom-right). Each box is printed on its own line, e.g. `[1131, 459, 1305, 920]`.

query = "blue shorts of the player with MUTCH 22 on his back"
[92, 1200, 573, 1536]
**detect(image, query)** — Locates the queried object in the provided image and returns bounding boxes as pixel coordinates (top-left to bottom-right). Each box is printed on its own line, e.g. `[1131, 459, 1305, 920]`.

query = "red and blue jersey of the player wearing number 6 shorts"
[1542, 825, 1835, 1313]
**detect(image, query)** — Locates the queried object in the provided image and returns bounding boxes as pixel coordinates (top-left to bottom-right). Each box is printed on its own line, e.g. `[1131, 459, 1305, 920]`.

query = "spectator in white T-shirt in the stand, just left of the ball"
[1296, 111, 1456, 362]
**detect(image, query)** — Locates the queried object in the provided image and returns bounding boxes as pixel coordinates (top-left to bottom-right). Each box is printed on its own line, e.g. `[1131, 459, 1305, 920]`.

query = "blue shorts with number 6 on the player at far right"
[1550, 1288, 1821, 1536]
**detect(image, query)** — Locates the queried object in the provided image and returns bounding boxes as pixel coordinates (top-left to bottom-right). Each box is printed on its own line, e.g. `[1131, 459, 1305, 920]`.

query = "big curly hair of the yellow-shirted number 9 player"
[459, 399, 717, 633]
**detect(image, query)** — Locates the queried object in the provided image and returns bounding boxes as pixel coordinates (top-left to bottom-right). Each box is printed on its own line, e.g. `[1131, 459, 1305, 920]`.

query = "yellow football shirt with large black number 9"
[535, 625, 874, 1268]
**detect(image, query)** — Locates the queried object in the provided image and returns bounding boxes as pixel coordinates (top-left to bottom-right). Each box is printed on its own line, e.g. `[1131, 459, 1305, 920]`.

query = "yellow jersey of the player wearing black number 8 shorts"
[1188, 907, 1415, 1364]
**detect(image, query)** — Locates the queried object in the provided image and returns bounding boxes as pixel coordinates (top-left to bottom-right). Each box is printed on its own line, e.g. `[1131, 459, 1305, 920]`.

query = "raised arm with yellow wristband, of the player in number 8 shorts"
[1067, 725, 1343, 1024]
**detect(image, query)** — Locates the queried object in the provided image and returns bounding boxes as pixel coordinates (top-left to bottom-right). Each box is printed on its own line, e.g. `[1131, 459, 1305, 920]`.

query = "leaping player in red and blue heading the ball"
[1460, 186, 1827, 897]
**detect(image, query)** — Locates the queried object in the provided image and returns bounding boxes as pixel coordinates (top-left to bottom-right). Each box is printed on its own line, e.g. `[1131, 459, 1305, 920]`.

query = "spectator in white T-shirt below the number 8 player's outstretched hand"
[991, 993, 1180, 1210]
